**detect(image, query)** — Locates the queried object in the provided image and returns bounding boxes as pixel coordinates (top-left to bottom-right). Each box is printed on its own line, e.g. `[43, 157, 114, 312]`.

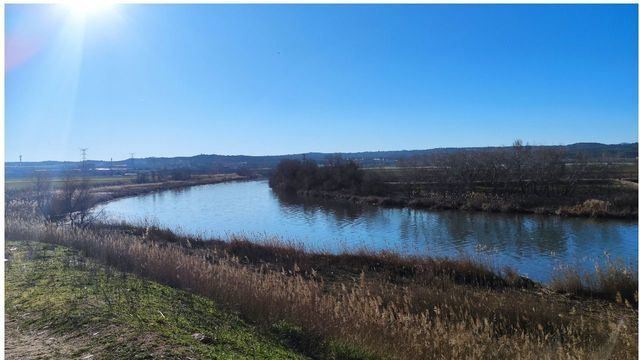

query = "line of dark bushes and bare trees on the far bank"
[269, 140, 600, 196]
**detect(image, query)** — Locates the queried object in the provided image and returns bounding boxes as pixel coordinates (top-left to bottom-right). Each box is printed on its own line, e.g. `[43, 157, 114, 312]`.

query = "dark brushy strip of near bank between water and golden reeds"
[94, 223, 638, 304]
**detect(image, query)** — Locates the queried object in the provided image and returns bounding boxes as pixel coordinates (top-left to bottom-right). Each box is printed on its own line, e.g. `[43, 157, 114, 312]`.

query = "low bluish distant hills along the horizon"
[5, 143, 638, 178]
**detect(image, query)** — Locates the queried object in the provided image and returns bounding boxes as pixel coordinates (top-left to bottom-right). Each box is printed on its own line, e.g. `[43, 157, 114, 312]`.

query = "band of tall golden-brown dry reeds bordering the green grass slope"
[5, 212, 637, 359]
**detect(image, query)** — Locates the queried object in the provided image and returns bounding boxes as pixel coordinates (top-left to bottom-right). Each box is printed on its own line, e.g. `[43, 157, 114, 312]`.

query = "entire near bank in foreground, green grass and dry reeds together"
[5, 176, 638, 359]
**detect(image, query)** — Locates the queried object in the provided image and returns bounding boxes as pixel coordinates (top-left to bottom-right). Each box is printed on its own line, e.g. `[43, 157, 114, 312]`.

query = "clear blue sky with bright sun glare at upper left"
[5, 5, 638, 161]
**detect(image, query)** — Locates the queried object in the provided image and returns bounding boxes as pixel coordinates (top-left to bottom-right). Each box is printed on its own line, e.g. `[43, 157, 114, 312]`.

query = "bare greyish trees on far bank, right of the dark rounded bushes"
[402, 141, 586, 196]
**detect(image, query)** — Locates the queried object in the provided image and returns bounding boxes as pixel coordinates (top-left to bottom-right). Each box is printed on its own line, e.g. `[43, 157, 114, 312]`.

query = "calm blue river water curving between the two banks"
[92, 181, 638, 282]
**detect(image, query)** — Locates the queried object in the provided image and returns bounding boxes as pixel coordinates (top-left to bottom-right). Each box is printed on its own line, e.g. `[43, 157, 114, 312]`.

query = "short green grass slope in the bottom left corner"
[5, 241, 310, 359]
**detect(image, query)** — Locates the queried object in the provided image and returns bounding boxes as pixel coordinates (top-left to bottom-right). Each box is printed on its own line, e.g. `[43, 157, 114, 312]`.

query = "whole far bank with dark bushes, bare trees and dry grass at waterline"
[269, 141, 638, 219]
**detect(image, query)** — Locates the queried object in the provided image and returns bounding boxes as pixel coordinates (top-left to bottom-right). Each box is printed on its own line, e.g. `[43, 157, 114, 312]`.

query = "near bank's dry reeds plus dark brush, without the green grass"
[5, 218, 638, 359]
